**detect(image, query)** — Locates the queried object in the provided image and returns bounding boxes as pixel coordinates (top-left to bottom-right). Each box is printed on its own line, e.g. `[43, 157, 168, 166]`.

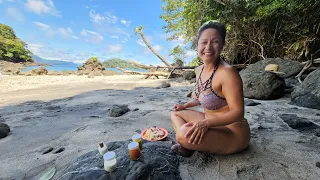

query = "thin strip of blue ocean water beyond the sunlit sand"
[21, 64, 147, 73]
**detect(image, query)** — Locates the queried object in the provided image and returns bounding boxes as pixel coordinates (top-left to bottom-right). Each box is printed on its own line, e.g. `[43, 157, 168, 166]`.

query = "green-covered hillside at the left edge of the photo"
[0, 24, 32, 62]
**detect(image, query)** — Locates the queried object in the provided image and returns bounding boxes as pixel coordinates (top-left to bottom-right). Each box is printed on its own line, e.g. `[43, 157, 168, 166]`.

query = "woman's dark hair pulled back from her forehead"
[197, 20, 226, 44]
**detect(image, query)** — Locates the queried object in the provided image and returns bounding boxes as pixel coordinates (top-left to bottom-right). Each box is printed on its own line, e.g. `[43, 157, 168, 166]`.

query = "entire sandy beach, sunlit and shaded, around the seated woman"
[0, 75, 320, 180]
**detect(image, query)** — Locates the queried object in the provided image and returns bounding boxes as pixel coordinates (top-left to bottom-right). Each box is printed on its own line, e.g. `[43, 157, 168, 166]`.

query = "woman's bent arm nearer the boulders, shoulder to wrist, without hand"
[206, 66, 244, 127]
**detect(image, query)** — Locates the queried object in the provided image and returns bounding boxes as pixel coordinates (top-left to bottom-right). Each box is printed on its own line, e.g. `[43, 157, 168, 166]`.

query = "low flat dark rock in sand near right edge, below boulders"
[280, 114, 320, 133]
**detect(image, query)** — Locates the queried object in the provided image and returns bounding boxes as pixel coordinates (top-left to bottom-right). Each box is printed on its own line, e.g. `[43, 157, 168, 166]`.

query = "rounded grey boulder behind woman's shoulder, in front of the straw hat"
[240, 69, 285, 100]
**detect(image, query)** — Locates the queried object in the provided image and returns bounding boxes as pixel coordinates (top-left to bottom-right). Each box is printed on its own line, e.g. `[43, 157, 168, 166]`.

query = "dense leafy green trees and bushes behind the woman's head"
[160, 0, 320, 63]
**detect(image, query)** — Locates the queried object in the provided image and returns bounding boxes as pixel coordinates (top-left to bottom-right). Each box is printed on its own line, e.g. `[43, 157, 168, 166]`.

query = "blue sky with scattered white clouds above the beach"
[0, 0, 196, 65]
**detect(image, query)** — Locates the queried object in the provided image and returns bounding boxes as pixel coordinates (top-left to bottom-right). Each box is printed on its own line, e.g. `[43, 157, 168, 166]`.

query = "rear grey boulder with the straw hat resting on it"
[243, 58, 303, 78]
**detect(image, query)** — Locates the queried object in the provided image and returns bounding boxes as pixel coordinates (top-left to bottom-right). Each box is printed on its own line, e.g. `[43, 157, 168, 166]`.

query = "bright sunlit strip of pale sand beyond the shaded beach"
[0, 75, 188, 107]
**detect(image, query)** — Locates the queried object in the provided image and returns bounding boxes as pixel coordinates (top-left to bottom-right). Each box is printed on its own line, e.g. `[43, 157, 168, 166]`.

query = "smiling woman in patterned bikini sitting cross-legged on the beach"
[171, 21, 250, 156]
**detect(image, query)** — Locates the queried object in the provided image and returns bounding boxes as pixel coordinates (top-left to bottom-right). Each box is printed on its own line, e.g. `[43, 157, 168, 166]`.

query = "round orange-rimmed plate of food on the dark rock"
[141, 126, 168, 141]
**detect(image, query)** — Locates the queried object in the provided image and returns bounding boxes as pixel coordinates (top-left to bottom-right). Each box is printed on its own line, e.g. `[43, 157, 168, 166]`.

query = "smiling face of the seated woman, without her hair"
[198, 28, 223, 62]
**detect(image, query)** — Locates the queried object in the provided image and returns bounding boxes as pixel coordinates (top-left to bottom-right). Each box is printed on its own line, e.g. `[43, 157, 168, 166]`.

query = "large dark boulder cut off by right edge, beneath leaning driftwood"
[291, 69, 320, 110]
